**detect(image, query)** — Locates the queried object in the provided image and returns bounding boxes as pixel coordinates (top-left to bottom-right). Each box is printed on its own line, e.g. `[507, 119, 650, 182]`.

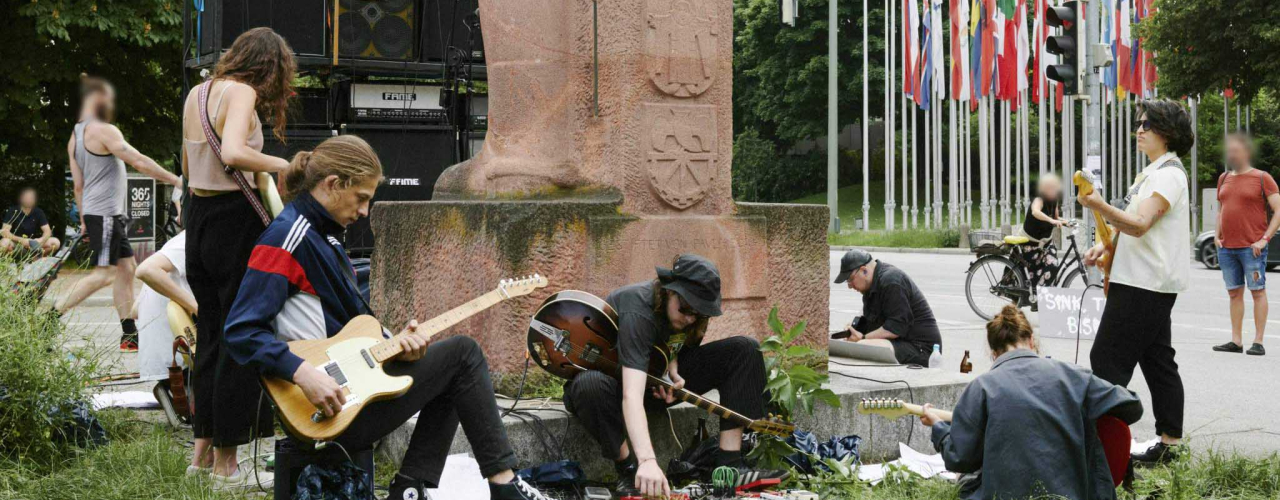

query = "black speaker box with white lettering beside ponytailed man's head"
[342, 123, 457, 254]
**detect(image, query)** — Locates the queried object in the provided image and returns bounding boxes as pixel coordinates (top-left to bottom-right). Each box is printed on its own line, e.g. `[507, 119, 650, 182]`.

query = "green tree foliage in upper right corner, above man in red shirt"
[1138, 0, 1280, 104]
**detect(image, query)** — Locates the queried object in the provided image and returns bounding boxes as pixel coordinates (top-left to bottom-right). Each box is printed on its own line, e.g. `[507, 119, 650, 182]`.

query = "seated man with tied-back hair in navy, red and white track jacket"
[225, 136, 560, 500]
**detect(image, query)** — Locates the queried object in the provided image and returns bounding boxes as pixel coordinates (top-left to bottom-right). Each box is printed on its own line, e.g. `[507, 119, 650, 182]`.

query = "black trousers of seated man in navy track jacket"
[337, 336, 516, 487]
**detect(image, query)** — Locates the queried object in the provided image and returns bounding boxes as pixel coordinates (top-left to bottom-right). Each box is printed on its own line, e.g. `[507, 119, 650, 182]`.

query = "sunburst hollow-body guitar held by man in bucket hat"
[527, 290, 795, 437]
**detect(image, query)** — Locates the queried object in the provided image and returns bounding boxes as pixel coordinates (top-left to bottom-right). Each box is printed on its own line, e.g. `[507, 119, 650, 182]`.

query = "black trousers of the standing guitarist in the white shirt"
[1089, 283, 1185, 437]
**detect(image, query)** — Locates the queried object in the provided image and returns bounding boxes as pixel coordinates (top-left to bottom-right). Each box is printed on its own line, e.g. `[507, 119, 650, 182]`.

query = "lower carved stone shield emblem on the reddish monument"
[641, 104, 719, 210]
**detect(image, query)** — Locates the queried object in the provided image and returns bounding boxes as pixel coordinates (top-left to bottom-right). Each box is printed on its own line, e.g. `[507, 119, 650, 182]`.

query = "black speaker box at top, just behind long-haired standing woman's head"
[196, 0, 333, 56]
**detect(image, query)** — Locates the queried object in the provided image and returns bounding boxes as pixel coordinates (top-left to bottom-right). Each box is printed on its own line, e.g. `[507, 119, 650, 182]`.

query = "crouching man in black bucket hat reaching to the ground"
[564, 253, 786, 495]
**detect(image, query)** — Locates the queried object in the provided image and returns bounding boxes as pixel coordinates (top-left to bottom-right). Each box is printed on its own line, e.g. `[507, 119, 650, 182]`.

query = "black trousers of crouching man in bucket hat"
[564, 336, 764, 460]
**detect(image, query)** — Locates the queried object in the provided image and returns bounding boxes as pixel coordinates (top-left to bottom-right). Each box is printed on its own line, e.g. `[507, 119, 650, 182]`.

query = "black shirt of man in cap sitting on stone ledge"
[854, 261, 942, 350]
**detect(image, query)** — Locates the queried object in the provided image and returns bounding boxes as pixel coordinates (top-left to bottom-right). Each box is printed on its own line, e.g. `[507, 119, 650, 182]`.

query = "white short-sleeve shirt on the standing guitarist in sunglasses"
[1111, 152, 1192, 293]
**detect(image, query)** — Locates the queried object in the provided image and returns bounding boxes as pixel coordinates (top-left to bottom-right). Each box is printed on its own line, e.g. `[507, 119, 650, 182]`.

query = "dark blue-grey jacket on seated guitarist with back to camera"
[932, 349, 1142, 500]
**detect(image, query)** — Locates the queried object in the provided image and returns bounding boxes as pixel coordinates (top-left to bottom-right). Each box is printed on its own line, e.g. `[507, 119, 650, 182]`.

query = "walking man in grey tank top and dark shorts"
[56, 74, 182, 352]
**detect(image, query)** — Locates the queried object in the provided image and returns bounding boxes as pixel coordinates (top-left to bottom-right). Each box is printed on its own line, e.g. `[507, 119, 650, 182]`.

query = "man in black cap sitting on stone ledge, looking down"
[833, 248, 942, 366]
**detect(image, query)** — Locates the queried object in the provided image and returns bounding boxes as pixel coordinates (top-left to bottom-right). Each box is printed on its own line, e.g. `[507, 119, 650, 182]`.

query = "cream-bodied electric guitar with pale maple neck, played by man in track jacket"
[262, 275, 547, 441]
